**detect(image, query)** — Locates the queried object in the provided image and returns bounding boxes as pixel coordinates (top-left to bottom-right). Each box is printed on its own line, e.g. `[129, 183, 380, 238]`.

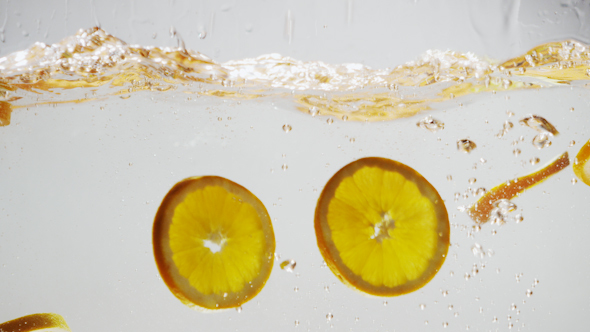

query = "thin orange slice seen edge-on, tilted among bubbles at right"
[467, 152, 570, 224]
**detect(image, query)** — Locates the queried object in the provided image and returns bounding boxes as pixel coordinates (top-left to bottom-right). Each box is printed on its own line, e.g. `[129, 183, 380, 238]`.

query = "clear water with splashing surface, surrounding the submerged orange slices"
[0, 26, 590, 331]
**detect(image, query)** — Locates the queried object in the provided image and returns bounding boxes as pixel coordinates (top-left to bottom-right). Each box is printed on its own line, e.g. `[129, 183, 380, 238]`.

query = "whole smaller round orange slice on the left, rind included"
[153, 176, 275, 310]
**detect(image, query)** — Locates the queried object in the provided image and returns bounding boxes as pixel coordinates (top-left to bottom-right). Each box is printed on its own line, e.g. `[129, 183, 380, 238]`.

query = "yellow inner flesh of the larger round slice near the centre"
[326, 166, 439, 288]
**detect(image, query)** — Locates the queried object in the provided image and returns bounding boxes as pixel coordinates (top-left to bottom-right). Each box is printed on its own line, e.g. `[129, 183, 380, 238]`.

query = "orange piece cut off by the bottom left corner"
[0, 313, 71, 332]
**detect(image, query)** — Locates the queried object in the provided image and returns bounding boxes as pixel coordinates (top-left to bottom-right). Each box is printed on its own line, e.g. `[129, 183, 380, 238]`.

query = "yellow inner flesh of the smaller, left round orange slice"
[169, 186, 266, 295]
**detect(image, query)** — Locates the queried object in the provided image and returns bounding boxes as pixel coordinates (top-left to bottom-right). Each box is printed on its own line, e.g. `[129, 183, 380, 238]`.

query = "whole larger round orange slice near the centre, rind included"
[315, 158, 450, 296]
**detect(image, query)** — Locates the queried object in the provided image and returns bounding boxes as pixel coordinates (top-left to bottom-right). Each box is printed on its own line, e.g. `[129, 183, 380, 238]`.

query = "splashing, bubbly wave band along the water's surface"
[0, 28, 590, 125]
